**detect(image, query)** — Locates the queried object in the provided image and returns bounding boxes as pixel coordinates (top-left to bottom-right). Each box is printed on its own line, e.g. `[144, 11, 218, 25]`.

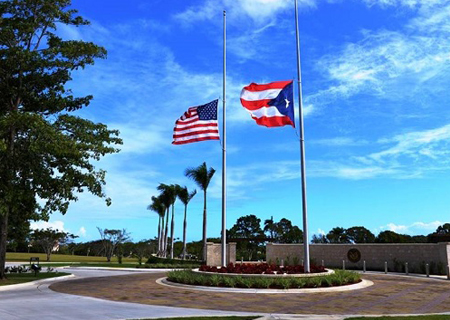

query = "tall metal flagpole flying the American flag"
[222, 10, 227, 267]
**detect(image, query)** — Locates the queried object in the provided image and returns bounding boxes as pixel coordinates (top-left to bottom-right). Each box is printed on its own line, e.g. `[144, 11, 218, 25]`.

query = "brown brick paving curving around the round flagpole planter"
[50, 273, 450, 315]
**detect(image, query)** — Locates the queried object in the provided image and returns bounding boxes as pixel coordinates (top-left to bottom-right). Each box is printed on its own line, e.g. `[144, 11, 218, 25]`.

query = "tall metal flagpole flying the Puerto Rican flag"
[295, 0, 311, 273]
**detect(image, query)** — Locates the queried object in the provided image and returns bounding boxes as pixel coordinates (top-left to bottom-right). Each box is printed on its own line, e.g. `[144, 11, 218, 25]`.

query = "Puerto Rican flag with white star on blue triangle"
[241, 80, 295, 127]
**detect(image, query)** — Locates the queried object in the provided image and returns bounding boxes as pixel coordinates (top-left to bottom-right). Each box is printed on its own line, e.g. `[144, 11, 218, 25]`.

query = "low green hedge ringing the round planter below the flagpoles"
[167, 270, 361, 289]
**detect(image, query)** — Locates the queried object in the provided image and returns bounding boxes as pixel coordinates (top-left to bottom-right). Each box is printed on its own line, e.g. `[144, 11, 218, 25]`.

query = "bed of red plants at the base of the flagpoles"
[198, 263, 327, 274]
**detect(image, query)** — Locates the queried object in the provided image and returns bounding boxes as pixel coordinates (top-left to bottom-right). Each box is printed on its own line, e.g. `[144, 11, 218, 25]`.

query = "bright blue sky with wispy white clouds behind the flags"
[33, 0, 450, 241]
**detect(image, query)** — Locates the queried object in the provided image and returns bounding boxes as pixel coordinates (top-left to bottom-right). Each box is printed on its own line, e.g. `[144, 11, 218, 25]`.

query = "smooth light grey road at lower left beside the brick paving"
[0, 268, 266, 320]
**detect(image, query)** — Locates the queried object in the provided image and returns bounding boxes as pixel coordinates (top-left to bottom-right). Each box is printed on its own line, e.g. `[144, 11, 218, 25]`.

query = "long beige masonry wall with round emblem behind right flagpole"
[266, 243, 450, 274]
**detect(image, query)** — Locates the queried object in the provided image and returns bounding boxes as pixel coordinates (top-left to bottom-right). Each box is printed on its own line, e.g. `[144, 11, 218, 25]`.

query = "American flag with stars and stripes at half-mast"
[172, 100, 220, 144]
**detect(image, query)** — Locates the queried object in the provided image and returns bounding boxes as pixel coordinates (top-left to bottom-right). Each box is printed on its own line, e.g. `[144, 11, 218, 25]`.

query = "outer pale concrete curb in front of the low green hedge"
[156, 278, 373, 294]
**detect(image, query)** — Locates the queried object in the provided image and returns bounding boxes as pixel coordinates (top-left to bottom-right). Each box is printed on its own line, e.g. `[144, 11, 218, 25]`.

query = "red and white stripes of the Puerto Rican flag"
[241, 80, 295, 127]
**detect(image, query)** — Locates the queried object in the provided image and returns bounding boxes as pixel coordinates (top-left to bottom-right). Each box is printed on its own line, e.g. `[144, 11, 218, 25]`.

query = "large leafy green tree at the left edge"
[0, 0, 121, 279]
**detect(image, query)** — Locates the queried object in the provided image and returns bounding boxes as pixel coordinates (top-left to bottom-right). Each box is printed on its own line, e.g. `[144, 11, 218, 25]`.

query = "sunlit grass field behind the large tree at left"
[6, 252, 137, 267]
